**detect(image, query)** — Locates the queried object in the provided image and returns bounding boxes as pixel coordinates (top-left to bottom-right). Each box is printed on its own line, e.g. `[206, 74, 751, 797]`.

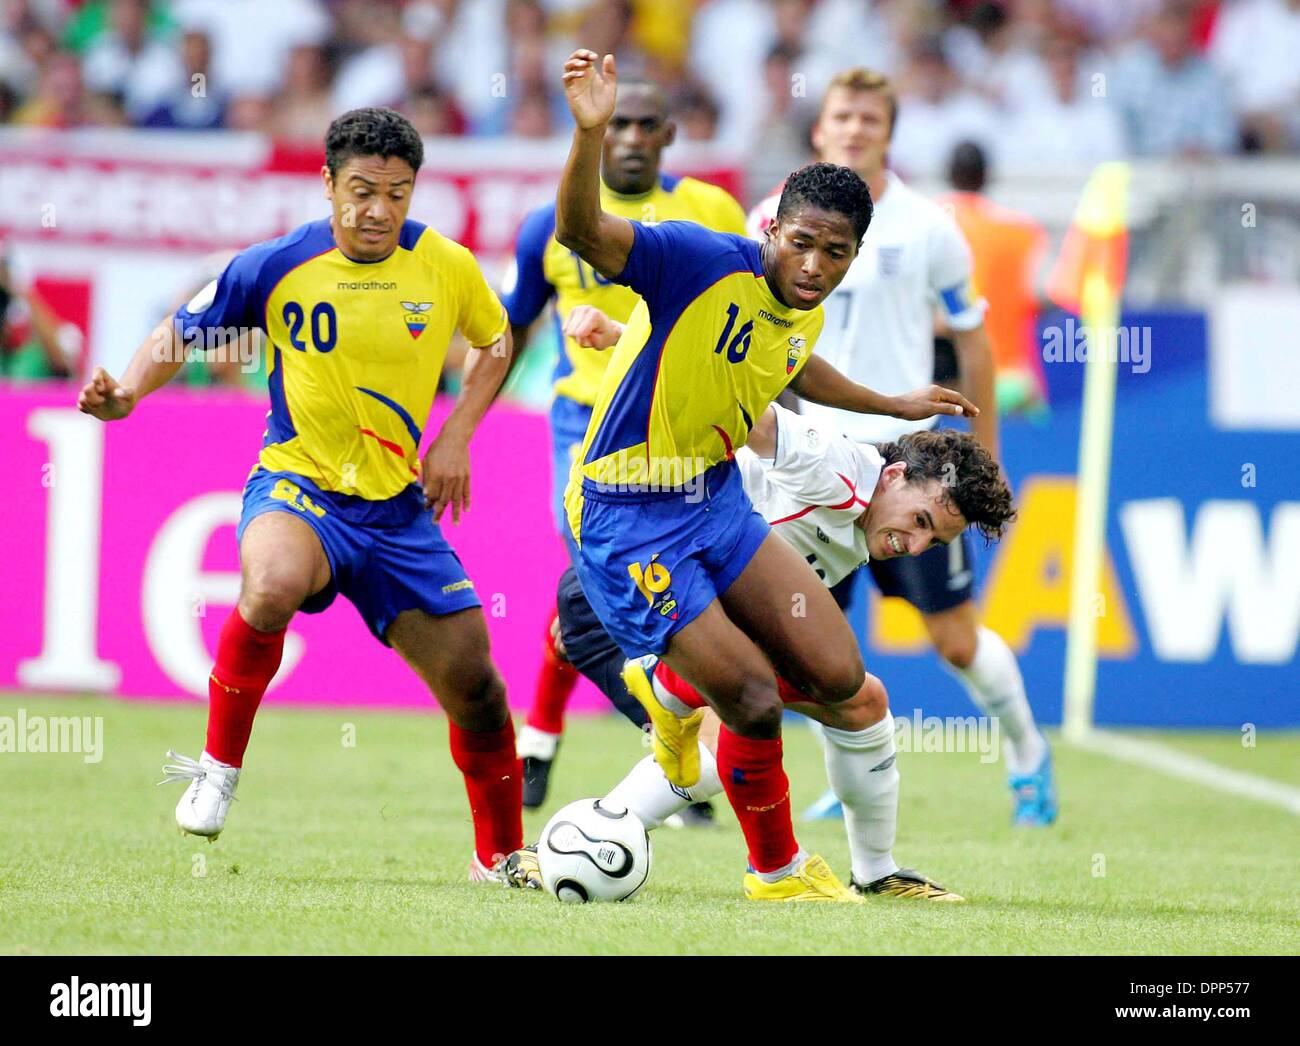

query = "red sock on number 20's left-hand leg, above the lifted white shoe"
[207, 607, 285, 767]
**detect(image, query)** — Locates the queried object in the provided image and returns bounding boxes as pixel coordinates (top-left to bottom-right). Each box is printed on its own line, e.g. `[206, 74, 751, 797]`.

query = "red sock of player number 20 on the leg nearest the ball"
[450, 719, 524, 868]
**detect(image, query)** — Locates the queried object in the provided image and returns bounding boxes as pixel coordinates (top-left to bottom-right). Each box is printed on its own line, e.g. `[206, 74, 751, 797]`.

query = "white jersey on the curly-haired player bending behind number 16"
[736, 404, 884, 587]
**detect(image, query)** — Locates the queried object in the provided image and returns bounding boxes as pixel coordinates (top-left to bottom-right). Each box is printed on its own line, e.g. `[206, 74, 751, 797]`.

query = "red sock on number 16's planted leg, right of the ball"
[718, 726, 800, 872]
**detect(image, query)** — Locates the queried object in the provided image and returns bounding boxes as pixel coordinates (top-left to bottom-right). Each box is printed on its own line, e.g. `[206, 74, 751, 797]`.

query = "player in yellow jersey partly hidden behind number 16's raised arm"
[504, 81, 745, 808]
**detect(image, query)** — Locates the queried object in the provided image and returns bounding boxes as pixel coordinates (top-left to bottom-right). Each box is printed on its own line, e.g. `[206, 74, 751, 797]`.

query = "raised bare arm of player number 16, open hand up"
[555, 49, 634, 278]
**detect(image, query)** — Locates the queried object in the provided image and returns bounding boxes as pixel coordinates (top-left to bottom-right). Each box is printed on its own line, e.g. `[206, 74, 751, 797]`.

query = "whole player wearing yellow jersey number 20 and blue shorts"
[79, 109, 523, 880]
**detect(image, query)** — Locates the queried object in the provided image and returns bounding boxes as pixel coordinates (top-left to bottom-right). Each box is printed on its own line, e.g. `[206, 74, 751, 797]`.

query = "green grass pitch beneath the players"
[0, 694, 1300, 955]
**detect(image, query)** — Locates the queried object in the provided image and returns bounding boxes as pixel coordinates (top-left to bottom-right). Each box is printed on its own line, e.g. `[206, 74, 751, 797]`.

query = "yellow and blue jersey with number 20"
[176, 220, 506, 502]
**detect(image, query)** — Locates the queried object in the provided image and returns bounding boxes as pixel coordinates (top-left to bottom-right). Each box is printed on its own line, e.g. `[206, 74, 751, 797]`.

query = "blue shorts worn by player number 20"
[237, 468, 482, 646]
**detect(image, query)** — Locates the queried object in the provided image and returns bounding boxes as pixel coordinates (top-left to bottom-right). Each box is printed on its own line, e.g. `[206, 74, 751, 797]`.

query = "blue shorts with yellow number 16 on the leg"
[567, 461, 770, 657]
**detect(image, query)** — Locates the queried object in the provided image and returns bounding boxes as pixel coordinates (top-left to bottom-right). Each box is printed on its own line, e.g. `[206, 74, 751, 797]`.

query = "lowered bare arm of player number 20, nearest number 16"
[420, 326, 514, 524]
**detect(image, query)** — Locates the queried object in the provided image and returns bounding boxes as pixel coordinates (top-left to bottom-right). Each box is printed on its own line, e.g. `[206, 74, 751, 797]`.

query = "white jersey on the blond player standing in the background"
[749, 172, 985, 443]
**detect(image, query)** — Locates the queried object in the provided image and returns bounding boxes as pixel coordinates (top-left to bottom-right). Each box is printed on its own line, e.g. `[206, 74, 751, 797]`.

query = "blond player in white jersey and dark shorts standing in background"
[749, 69, 1057, 825]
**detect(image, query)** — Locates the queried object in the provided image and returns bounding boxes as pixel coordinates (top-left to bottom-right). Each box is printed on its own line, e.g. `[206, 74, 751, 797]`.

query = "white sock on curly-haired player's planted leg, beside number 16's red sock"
[822, 712, 898, 886]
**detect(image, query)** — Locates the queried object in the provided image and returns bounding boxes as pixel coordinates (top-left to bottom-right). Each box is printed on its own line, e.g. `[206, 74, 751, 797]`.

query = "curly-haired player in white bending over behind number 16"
[493, 309, 1014, 900]
